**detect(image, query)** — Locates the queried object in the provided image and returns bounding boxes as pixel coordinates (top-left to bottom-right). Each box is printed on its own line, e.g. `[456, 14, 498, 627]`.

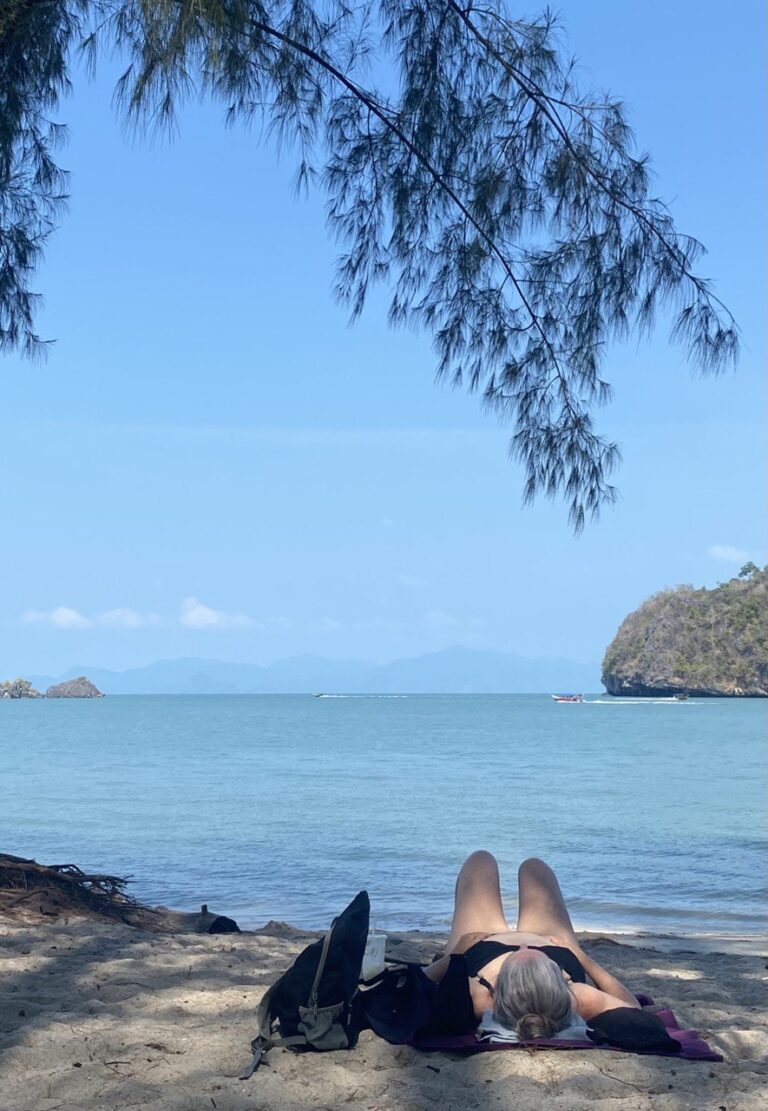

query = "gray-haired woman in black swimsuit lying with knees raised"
[426, 850, 639, 1041]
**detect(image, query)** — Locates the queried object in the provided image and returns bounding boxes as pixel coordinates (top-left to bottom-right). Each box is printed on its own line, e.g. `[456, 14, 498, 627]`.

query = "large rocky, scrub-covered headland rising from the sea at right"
[602, 563, 768, 698]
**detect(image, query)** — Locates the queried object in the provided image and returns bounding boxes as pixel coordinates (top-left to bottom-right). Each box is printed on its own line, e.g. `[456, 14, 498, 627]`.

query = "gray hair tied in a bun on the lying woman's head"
[493, 955, 571, 1041]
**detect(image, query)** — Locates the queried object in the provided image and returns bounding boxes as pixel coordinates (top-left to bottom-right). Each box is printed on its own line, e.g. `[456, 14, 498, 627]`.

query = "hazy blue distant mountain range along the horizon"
[27, 648, 601, 694]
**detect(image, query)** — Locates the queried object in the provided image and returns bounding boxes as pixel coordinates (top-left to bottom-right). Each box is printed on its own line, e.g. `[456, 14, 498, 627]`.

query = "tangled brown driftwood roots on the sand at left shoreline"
[0, 853, 151, 924]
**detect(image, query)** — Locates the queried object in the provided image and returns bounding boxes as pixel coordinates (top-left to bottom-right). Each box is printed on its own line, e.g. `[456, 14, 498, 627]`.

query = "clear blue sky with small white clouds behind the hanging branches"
[0, 0, 766, 678]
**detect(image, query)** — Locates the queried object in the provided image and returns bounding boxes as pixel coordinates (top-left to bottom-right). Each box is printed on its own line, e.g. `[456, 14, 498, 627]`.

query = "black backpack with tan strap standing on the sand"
[240, 891, 370, 1080]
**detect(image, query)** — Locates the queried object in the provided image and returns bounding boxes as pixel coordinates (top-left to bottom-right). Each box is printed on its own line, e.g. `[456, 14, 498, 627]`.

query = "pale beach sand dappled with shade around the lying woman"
[0, 917, 768, 1111]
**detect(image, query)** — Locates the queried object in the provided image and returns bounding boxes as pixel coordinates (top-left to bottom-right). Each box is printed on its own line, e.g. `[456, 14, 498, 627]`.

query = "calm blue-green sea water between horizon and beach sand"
[0, 694, 768, 934]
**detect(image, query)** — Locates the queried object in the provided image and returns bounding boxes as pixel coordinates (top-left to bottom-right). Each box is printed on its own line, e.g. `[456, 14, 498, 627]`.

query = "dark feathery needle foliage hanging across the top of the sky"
[0, 0, 738, 530]
